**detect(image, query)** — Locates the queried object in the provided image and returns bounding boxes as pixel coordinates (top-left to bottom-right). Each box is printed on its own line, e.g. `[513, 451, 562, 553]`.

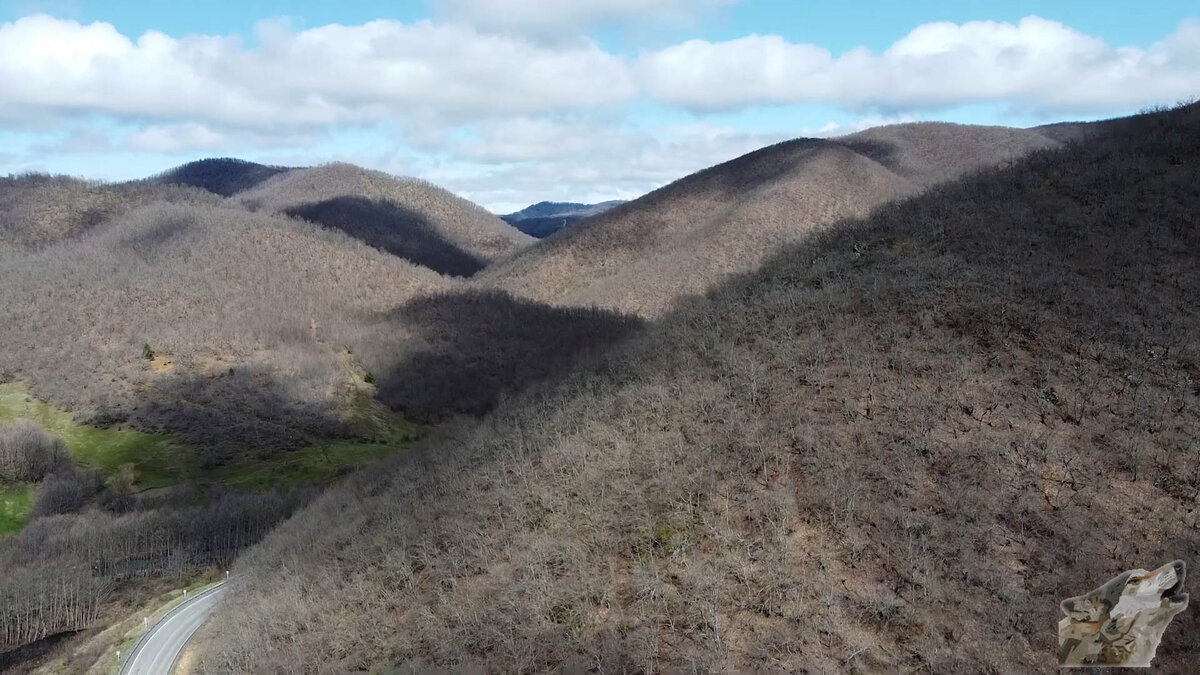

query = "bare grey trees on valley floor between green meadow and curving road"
[0, 419, 311, 653]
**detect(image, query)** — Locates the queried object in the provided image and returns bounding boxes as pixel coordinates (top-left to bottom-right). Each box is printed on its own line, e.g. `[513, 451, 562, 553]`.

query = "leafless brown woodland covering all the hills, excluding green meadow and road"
[0, 106, 1200, 673]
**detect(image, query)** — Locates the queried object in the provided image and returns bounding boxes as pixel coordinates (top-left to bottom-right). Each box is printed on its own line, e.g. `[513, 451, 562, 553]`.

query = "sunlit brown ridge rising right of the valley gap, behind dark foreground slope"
[481, 123, 1058, 316]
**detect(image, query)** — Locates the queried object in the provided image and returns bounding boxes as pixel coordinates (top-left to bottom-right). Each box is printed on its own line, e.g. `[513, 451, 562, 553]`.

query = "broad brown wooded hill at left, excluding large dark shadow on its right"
[0, 199, 450, 452]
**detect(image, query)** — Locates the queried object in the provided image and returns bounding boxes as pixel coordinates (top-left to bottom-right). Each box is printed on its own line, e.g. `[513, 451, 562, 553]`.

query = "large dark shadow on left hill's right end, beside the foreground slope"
[379, 291, 642, 422]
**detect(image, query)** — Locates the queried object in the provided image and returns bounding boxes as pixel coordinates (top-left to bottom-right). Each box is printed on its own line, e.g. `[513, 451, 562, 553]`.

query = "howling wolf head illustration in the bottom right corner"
[1058, 560, 1188, 668]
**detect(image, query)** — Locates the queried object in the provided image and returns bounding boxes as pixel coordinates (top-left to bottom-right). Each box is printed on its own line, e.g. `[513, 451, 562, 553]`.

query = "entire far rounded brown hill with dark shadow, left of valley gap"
[235, 163, 533, 267]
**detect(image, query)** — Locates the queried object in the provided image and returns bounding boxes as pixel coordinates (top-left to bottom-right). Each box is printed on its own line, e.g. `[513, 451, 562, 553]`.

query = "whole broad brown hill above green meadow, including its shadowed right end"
[0, 194, 638, 454]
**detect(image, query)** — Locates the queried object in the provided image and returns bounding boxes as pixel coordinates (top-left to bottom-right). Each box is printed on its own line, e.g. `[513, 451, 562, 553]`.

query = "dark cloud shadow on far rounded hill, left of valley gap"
[287, 196, 485, 276]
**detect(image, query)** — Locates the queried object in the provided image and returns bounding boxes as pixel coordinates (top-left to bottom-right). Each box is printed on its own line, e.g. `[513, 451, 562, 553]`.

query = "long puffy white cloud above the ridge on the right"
[636, 17, 1200, 110]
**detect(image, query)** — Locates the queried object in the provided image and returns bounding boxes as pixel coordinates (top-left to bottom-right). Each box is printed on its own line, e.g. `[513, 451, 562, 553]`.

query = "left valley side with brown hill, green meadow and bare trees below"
[0, 179, 640, 671]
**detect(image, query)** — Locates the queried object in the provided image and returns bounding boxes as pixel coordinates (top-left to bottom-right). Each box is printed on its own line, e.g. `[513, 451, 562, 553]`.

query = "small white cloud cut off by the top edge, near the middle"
[430, 0, 742, 36]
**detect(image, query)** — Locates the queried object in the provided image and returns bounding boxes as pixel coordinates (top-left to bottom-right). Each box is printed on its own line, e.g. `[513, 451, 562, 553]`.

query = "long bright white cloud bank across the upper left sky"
[0, 16, 634, 129]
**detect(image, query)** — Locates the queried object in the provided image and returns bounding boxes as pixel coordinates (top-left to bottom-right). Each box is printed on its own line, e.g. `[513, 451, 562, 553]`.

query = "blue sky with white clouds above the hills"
[0, 0, 1200, 213]
